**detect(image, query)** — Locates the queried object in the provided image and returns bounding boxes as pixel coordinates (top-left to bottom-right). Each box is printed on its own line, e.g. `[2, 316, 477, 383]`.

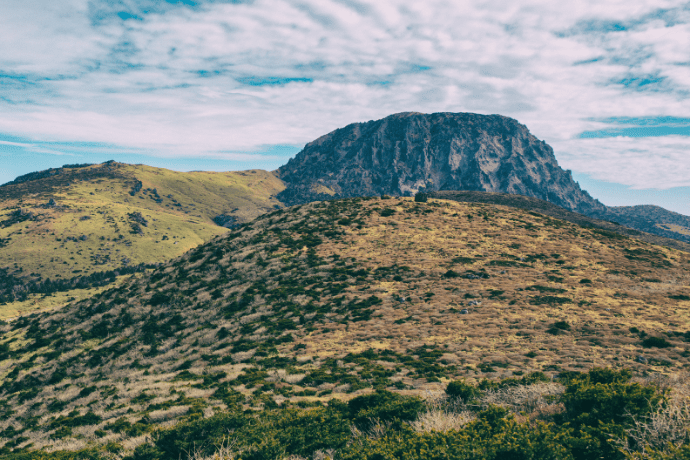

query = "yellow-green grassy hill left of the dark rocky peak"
[0, 162, 283, 315]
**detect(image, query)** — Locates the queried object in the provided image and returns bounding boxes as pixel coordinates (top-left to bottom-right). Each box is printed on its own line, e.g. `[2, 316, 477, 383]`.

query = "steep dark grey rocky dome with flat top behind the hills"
[277, 113, 606, 214]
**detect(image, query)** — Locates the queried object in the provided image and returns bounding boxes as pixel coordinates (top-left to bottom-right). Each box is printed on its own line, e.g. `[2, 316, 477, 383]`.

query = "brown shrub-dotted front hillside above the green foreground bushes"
[0, 198, 690, 458]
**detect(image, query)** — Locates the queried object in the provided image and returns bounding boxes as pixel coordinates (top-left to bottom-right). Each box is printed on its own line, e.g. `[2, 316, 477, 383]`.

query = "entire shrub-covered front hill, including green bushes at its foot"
[0, 196, 690, 459]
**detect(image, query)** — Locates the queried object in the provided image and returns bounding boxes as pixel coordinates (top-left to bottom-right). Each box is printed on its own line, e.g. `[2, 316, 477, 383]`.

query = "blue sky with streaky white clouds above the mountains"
[0, 0, 690, 215]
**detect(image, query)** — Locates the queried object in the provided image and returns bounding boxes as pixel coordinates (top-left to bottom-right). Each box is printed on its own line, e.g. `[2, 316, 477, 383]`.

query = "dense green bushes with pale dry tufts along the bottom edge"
[0, 369, 690, 460]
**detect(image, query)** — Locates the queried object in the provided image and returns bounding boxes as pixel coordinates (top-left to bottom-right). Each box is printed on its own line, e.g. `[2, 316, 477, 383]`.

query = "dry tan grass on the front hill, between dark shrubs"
[0, 199, 690, 448]
